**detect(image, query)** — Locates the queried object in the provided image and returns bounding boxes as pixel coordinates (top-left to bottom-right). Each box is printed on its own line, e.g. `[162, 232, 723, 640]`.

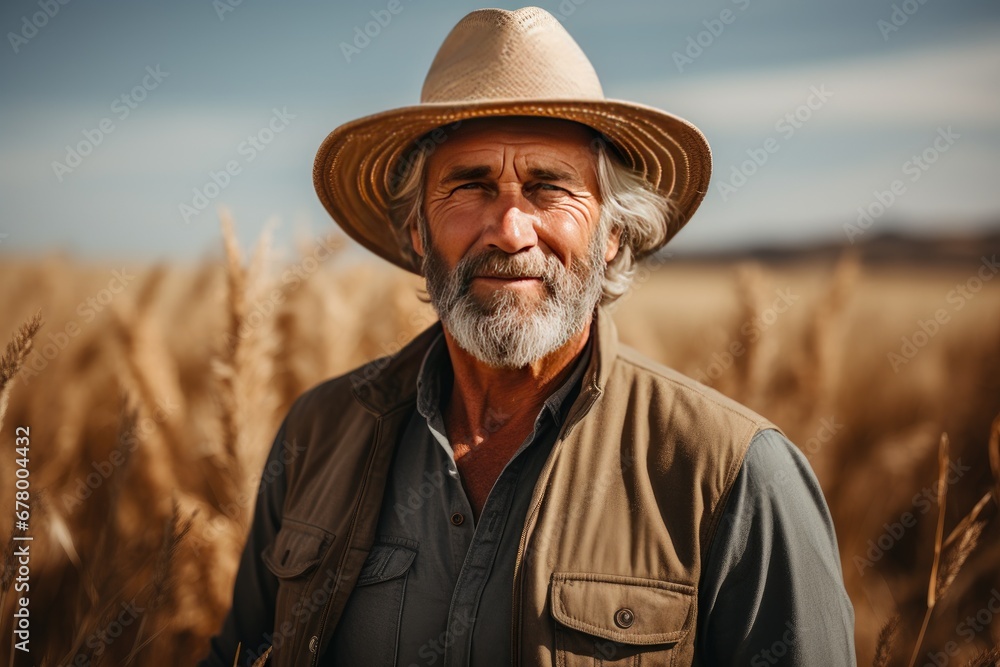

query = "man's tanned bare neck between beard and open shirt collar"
[444, 315, 593, 433]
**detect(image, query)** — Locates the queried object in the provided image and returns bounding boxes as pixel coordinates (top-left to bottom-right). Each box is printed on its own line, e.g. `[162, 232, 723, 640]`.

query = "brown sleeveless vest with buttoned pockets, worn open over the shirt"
[252, 309, 774, 667]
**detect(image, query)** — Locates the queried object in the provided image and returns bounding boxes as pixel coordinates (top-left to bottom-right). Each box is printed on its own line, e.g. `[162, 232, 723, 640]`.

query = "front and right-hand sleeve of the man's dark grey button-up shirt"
[322, 336, 854, 667]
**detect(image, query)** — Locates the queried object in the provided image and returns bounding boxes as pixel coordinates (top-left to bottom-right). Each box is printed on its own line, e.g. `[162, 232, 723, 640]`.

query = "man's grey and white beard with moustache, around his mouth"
[423, 234, 607, 368]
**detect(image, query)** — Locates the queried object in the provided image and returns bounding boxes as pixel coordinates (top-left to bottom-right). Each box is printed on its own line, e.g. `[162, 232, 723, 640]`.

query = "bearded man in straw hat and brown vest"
[205, 8, 854, 666]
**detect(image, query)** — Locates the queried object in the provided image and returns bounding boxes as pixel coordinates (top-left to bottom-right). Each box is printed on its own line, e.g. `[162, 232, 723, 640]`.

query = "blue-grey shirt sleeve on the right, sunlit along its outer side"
[695, 429, 856, 667]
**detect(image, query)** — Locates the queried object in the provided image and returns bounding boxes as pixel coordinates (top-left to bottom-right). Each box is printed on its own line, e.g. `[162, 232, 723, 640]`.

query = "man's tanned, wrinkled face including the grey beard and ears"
[411, 118, 618, 367]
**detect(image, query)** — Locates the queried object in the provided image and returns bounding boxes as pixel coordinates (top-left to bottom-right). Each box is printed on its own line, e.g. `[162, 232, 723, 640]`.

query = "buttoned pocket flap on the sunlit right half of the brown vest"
[552, 572, 695, 645]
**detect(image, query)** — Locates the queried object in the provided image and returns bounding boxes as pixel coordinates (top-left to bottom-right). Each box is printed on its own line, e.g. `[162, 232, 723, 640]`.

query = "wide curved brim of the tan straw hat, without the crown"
[313, 100, 712, 275]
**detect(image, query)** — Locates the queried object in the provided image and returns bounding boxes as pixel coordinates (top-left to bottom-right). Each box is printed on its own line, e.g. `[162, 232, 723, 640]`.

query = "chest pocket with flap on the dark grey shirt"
[328, 536, 417, 667]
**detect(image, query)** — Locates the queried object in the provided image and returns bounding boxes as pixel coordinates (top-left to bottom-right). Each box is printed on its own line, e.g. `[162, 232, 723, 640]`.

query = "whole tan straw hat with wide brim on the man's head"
[313, 7, 712, 274]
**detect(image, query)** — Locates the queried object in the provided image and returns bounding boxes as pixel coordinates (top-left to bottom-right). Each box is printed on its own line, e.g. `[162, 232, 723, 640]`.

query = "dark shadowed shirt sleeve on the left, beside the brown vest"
[198, 424, 288, 667]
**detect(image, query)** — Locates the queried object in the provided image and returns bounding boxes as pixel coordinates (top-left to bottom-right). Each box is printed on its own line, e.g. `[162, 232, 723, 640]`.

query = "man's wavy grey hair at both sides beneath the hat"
[389, 130, 676, 305]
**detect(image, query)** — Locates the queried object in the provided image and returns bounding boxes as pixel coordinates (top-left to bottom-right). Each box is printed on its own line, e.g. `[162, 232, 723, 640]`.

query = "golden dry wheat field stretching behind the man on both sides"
[0, 220, 1000, 667]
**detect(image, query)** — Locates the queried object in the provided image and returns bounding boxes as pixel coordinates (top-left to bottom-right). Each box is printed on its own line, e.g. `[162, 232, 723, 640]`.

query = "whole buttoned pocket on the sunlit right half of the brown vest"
[550, 572, 695, 667]
